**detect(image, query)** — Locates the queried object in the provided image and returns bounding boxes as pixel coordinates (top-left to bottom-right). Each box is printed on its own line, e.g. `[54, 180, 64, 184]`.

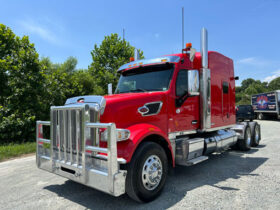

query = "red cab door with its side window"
[173, 69, 199, 132]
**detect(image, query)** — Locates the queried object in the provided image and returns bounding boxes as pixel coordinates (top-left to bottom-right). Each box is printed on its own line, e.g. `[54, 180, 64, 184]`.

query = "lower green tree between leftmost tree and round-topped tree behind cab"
[41, 57, 102, 110]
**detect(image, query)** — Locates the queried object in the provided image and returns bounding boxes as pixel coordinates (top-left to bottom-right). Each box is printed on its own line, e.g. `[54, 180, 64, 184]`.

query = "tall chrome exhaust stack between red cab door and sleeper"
[200, 28, 211, 131]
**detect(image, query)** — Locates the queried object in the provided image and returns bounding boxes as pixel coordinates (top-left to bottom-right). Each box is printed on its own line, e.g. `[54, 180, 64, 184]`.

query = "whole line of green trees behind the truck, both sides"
[0, 24, 280, 144]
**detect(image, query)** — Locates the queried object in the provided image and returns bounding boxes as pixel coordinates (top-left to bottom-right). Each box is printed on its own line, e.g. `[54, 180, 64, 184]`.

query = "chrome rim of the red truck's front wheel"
[142, 155, 162, 190]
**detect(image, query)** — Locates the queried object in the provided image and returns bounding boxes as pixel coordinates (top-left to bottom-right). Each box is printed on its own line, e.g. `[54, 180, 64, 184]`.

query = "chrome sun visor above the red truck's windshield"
[117, 55, 180, 72]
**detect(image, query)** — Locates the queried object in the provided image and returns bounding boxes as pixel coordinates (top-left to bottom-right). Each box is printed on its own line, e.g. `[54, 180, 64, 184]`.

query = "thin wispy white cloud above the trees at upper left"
[19, 20, 59, 44]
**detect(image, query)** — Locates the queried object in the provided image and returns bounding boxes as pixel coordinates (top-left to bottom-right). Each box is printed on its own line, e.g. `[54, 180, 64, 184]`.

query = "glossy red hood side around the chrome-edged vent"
[103, 92, 167, 130]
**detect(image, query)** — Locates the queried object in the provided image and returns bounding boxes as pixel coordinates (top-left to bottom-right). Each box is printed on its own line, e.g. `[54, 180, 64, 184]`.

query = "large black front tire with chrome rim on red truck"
[125, 142, 168, 202]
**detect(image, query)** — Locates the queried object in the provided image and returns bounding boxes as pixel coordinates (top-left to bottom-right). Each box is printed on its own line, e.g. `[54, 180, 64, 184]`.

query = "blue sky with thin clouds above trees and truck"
[0, 0, 280, 85]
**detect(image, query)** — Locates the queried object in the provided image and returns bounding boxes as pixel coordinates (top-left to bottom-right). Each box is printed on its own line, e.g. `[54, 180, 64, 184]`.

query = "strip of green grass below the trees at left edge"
[0, 142, 36, 162]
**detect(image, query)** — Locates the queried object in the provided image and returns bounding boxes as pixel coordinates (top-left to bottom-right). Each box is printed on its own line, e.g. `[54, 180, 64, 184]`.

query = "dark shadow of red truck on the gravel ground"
[44, 145, 268, 209]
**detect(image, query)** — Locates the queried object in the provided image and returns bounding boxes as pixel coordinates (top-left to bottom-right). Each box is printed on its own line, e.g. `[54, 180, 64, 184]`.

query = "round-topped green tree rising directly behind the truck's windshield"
[89, 34, 144, 94]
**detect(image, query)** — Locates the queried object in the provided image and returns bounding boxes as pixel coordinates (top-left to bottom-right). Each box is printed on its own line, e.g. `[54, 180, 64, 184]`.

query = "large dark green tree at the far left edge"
[0, 24, 44, 142]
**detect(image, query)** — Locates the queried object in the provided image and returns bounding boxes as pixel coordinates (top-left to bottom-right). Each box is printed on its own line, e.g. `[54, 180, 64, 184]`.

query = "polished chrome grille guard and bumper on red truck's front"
[36, 104, 126, 196]
